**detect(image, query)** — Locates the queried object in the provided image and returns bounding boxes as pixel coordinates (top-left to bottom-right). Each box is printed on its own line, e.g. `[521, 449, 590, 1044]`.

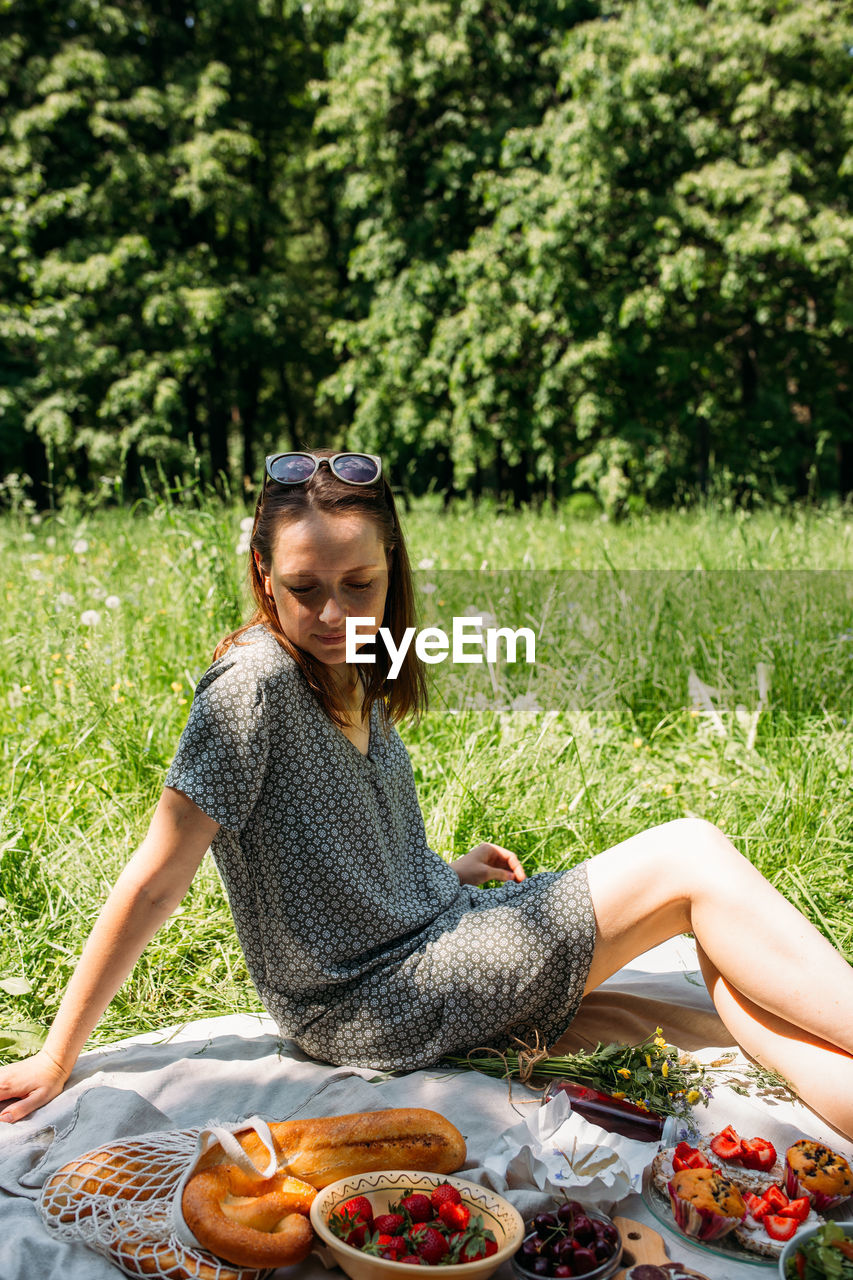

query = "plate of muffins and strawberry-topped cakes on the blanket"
[651, 1125, 853, 1257]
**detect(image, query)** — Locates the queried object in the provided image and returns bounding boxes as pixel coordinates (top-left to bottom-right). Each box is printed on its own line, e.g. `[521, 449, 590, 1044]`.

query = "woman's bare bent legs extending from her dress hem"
[587, 818, 853, 1137]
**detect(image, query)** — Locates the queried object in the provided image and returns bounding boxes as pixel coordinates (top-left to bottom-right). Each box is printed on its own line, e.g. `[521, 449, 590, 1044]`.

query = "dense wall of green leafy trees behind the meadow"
[0, 0, 853, 512]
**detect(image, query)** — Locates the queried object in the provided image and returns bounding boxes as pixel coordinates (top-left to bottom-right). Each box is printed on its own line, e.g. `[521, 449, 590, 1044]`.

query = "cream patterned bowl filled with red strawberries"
[311, 1170, 524, 1280]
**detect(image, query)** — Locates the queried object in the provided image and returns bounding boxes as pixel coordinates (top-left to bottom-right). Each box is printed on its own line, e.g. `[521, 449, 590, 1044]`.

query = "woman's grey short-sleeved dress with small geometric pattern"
[165, 626, 596, 1070]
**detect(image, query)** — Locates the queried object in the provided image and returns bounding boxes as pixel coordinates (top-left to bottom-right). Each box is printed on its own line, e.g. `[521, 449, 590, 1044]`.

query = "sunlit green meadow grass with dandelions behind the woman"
[0, 500, 853, 1056]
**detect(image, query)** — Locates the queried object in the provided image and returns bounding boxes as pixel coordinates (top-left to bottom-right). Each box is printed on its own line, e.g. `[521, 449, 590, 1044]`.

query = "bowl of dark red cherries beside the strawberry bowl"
[512, 1199, 622, 1280]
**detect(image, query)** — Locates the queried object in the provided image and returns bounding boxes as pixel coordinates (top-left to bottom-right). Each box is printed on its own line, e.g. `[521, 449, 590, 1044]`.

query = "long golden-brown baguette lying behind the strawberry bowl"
[197, 1107, 466, 1190]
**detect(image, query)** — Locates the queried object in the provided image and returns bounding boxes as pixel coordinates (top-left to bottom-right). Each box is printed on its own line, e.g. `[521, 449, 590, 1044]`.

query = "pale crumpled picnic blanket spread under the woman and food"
[0, 940, 853, 1280]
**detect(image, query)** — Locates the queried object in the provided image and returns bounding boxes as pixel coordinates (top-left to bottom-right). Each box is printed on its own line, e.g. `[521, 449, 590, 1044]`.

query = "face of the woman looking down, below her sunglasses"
[255, 511, 388, 666]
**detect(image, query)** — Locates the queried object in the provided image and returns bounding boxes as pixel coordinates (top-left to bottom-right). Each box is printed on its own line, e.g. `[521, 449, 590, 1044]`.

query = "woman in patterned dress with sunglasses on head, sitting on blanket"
[0, 449, 853, 1137]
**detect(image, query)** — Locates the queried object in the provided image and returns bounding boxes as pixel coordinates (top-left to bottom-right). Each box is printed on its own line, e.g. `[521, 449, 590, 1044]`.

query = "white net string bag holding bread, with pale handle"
[38, 1116, 275, 1280]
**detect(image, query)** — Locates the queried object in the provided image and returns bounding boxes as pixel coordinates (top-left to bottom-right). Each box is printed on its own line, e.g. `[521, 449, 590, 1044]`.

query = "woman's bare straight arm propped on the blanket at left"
[0, 787, 219, 1121]
